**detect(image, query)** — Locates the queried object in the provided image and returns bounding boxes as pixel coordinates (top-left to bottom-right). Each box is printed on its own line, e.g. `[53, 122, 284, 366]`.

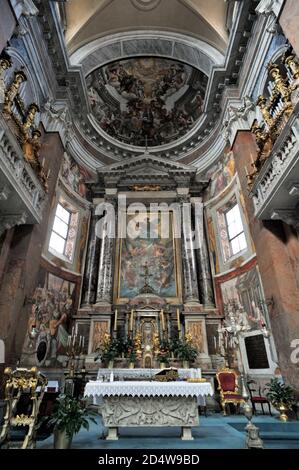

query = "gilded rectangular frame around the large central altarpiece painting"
[113, 208, 182, 305]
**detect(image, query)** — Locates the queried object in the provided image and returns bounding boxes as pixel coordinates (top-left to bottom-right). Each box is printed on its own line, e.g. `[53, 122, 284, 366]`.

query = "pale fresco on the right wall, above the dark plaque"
[221, 266, 267, 330]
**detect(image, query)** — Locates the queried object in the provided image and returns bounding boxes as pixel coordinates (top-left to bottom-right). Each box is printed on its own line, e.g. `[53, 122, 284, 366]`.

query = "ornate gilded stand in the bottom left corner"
[0, 367, 48, 449]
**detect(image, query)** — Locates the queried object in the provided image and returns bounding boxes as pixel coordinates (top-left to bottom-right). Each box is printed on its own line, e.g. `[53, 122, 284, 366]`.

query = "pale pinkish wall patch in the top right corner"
[279, 0, 299, 56]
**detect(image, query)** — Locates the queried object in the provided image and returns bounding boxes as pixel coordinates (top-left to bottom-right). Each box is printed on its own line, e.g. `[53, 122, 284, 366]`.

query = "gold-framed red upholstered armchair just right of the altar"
[216, 368, 244, 415]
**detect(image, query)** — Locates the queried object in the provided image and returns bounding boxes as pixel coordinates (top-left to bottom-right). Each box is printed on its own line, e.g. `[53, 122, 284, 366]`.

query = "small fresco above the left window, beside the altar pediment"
[60, 153, 90, 198]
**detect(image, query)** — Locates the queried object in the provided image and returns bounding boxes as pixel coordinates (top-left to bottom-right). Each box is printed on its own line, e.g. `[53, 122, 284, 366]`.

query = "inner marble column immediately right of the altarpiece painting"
[179, 195, 199, 303]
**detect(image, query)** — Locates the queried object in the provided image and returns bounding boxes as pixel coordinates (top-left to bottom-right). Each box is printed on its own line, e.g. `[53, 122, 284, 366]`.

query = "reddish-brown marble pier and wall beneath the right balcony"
[233, 131, 299, 391]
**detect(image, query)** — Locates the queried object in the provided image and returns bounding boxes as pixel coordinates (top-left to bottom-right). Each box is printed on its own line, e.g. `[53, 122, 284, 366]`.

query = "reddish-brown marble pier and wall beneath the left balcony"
[0, 129, 64, 366]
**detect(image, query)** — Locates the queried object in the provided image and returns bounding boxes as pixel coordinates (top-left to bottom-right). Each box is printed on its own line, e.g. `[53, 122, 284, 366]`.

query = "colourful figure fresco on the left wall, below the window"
[22, 269, 75, 367]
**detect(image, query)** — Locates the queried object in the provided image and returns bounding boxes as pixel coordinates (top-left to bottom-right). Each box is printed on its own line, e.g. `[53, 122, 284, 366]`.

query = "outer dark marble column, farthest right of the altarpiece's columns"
[192, 198, 215, 307]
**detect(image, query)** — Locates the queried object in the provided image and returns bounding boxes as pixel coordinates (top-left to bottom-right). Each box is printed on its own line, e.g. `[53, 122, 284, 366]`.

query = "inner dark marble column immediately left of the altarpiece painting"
[96, 196, 117, 304]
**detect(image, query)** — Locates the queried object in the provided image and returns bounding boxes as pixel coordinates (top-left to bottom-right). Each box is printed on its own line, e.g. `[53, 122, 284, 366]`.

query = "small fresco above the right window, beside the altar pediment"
[204, 152, 235, 200]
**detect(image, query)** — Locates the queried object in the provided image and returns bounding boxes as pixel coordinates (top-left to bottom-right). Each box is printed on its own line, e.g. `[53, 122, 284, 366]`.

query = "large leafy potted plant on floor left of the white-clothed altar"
[47, 394, 96, 449]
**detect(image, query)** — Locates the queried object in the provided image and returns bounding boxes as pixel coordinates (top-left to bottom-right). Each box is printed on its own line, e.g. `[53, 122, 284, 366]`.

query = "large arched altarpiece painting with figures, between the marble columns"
[118, 212, 178, 299]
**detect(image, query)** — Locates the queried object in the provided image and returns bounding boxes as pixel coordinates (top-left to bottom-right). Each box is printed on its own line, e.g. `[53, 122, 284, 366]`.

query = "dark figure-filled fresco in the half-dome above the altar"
[86, 57, 208, 147]
